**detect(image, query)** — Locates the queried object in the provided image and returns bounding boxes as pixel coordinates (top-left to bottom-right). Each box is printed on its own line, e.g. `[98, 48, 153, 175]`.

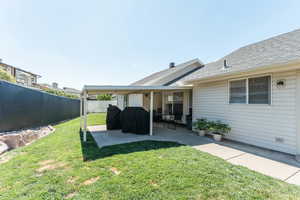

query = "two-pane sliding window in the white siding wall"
[229, 76, 271, 104]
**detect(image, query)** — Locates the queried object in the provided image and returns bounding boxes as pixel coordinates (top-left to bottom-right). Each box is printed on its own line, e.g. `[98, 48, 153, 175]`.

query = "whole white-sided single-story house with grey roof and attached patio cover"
[83, 29, 300, 155]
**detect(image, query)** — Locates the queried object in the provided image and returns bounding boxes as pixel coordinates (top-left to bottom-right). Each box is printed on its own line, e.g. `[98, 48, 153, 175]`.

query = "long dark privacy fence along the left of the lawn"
[0, 81, 80, 132]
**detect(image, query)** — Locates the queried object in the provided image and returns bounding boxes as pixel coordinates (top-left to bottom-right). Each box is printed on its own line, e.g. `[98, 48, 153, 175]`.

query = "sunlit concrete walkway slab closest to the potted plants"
[193, 143, 246, 160]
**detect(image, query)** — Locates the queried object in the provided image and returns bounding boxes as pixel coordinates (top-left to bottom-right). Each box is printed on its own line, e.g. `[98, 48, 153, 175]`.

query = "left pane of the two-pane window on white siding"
[229, 79, 246, 103]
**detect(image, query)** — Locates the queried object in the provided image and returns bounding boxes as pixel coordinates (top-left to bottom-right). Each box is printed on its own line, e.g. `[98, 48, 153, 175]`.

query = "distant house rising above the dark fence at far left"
[0, 59, 41, 87]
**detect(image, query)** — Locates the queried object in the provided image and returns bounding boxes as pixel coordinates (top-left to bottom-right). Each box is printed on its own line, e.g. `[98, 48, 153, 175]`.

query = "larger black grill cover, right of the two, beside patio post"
[121, 107, 150, 134]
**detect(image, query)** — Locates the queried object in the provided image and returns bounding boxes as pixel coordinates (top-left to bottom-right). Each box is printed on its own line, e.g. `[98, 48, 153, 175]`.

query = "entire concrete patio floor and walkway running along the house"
[88, 125, 300, 185]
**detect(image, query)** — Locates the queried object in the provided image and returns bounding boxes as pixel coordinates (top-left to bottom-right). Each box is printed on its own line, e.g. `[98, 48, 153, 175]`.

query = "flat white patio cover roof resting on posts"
[83, 85, 192, 94]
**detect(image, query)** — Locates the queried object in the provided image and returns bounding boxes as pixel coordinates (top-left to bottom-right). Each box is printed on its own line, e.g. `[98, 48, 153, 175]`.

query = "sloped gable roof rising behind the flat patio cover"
[131, 59, 202, 86]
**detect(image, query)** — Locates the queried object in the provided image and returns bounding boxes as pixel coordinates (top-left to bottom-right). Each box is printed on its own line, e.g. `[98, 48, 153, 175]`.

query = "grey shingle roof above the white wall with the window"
[182, 29, 300, 82]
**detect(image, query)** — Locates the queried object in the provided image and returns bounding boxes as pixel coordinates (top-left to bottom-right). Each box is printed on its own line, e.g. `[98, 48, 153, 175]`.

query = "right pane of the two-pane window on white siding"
[248, 76, 271, 104]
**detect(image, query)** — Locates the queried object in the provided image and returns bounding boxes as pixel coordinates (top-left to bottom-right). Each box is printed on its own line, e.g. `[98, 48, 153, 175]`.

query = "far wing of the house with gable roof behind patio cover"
[117, 59, 203, 124]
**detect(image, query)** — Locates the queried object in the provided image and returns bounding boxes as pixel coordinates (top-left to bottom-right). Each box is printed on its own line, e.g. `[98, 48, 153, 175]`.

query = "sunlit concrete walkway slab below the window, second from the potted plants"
[228, 153, 299, 181]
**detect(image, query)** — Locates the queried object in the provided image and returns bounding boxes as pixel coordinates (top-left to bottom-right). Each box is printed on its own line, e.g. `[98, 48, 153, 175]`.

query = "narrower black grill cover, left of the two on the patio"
[106, 105, 121, 130]
